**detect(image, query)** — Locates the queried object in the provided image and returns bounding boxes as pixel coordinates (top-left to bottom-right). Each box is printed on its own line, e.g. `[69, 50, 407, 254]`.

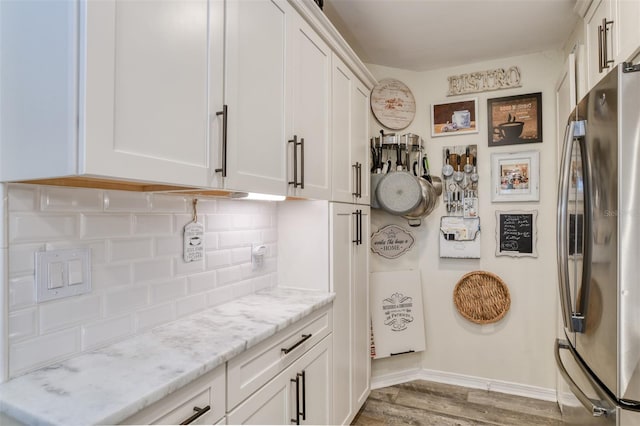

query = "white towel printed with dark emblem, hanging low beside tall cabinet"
[369, 270, 425, 359]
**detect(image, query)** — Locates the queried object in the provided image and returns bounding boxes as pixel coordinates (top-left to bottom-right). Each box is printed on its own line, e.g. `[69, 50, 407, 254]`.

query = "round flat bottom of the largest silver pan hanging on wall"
[376, 172, 422, 215]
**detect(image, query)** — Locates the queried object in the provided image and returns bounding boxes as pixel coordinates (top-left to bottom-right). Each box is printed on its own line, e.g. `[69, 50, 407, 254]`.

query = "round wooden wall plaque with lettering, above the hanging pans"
[371, 78, 416, 130]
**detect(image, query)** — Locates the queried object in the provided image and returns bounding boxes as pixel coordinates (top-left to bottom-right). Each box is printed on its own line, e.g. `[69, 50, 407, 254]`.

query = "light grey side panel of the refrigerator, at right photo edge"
[616, 65, 640, 404]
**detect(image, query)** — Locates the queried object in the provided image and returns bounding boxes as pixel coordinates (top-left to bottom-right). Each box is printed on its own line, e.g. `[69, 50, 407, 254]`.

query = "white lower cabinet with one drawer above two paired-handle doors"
[227, 308, 333, 424]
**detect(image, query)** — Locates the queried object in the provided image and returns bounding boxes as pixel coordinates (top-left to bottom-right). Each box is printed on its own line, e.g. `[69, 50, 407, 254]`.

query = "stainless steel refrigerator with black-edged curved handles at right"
[555, 63, 640, 426]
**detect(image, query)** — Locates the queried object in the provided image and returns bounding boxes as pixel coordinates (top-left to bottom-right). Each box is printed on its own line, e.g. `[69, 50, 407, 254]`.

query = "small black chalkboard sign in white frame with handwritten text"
[496, 211, 538, 257]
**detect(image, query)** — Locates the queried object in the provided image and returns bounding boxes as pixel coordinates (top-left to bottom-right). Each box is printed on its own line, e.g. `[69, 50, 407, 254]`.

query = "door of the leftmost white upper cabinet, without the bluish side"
[79, 0, 215, 186]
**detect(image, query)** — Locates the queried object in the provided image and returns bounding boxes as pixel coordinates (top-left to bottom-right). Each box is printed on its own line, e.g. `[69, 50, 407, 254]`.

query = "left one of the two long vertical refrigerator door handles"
[556, 121, 576, 333]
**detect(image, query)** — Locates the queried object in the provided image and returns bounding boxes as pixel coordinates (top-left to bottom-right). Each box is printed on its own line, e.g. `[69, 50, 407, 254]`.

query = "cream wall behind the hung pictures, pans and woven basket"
[369, 52, 564, 389]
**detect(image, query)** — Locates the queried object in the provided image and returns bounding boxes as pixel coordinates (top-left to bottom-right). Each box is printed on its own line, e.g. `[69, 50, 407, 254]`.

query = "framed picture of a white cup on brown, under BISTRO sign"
[431, 98, 478, 137]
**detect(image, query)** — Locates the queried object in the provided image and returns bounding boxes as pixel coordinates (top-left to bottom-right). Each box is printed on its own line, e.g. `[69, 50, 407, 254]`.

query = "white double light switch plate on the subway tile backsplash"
[36, 248, 91, 302]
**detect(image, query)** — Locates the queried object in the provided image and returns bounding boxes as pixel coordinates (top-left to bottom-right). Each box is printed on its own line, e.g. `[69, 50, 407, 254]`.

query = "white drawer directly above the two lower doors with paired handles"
[227, 307, 333, 411]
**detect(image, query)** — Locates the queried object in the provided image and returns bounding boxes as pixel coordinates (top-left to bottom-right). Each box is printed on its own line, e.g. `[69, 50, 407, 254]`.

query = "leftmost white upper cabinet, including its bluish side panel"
[0, 0, 223, 186]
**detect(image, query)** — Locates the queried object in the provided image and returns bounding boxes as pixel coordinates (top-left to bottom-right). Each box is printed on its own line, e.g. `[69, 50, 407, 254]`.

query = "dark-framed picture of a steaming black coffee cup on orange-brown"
[487, 93, 542, 147]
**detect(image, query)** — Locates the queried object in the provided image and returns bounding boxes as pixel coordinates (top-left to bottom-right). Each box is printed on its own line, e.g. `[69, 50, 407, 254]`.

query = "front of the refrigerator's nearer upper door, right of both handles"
[576, 68, 619, 398]
